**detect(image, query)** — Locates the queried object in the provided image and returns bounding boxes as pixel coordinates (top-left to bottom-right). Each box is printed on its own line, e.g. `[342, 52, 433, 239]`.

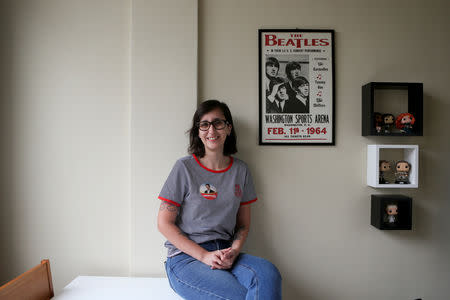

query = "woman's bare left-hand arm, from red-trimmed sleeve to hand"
[158, 201, 222, 269]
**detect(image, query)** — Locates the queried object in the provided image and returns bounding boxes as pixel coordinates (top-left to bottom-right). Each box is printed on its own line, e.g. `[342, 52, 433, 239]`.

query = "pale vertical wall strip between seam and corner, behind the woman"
[130, 0, 197, 276]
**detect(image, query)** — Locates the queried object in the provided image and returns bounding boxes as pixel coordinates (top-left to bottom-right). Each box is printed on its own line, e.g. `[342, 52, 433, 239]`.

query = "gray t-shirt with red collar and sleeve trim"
[158, 155, 257, 257]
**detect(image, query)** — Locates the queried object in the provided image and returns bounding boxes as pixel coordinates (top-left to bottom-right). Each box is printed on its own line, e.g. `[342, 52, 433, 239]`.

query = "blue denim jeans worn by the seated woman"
[166, 240, 281, 300]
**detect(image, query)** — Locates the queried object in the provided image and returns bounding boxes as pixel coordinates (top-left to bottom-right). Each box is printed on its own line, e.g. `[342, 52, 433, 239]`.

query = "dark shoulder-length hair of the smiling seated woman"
[188, 100, 237, 157]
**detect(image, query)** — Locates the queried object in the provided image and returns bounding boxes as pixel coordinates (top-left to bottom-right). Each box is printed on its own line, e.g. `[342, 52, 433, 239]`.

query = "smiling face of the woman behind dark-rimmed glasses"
[198, 108, 231, 153]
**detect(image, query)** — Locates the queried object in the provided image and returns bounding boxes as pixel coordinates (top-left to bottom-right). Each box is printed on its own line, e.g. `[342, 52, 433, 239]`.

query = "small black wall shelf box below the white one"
[370, 195, 412, 230]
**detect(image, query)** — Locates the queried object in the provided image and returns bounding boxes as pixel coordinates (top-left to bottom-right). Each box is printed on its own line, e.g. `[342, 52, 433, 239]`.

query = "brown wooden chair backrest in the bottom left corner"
[0, 259, 54, 300]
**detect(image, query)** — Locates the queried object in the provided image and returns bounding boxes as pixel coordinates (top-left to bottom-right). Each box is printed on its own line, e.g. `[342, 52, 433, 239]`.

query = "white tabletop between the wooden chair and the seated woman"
[52, 276, 182, 300]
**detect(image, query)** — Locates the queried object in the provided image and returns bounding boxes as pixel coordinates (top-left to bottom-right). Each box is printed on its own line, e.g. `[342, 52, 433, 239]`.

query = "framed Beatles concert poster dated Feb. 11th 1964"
[258, 29, 335, 146]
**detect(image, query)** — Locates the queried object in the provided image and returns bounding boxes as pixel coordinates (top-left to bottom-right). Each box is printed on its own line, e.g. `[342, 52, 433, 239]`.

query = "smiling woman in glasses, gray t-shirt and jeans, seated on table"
[158, 100, 281, 300]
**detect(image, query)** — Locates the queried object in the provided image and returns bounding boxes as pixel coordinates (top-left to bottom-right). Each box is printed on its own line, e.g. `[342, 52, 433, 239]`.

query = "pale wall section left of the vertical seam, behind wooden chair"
[0, 0, 130, 291]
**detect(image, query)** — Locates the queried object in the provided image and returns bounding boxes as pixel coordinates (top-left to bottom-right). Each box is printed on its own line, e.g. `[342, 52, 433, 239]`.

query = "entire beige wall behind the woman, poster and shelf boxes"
[0, 0, 450, 300]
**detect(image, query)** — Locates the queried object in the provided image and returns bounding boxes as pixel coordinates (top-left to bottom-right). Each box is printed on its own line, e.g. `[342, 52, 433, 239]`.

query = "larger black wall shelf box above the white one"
[361, 82, 423, 136]
